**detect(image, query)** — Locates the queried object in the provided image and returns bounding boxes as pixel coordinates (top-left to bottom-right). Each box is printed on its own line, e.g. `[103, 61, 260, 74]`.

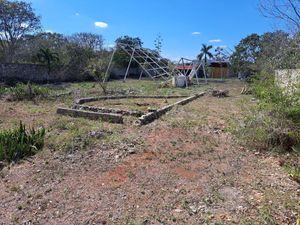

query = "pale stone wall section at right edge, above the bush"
[275, 69, 300, 92]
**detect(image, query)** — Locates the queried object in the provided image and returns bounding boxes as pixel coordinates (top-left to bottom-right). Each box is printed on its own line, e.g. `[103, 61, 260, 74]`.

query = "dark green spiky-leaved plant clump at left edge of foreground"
[0, 122, 45, 162]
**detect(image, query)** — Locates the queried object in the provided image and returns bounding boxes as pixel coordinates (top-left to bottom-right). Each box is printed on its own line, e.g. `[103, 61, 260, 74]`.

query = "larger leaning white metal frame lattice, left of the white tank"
[105, 43, 181, 81]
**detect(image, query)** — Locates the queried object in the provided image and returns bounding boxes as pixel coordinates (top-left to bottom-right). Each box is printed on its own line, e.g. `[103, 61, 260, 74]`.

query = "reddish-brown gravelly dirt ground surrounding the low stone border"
[0, 81, 300, 225]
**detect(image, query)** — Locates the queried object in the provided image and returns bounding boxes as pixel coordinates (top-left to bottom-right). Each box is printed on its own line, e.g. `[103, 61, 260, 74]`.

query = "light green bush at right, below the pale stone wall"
[239, 73, 300, 152]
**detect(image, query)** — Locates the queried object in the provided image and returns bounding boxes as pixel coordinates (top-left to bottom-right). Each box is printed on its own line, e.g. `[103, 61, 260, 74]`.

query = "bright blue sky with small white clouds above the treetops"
[26, 0, 273, 59]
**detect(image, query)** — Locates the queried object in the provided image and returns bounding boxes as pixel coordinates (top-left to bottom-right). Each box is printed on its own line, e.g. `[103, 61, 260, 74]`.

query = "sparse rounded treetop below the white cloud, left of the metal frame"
[69, 33, 104, 51]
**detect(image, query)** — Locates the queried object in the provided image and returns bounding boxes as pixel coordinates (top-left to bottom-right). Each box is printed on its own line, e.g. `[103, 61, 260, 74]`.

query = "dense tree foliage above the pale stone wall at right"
[230, 30, 300, 77]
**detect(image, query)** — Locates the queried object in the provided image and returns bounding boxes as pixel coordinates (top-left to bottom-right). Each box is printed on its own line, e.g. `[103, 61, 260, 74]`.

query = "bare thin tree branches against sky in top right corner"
[259, 0, 300, 32]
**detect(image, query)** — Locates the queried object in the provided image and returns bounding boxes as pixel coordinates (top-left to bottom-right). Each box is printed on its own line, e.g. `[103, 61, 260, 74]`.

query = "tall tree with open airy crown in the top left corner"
[0, 0, 41, 62]
